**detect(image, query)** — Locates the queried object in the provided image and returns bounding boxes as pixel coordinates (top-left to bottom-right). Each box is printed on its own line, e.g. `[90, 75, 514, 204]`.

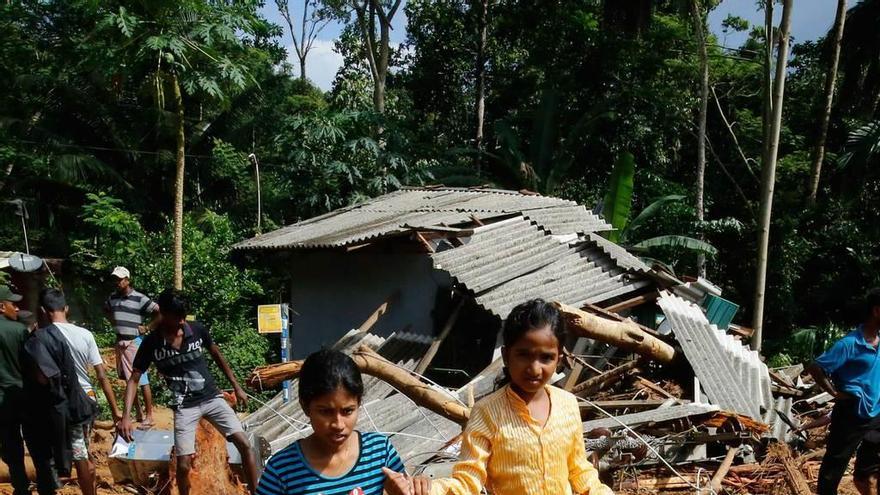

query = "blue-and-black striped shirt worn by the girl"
[257, 432, 403, 495]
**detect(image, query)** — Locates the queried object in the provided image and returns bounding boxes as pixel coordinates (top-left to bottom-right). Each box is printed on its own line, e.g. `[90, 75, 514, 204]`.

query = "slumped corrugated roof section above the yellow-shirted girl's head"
[432, 217, 649, 318]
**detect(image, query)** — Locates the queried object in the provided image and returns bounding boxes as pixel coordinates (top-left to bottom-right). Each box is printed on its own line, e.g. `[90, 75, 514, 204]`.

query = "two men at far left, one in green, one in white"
[0, 285, 113, 495]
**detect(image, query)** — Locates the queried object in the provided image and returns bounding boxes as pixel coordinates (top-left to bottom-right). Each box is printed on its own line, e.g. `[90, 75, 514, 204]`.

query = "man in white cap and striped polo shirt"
[104, 266, 160, 428]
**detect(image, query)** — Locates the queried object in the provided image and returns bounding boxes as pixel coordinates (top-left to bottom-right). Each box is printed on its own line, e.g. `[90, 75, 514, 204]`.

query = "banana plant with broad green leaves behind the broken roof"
[602, 153, 718, 256]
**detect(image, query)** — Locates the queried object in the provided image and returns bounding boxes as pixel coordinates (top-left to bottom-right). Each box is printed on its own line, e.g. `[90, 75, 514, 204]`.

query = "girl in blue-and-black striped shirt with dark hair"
[257, 350, 403, 495]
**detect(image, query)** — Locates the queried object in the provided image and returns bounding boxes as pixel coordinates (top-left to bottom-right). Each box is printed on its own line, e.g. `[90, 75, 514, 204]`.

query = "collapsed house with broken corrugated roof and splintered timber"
[234, 187, 820, 489]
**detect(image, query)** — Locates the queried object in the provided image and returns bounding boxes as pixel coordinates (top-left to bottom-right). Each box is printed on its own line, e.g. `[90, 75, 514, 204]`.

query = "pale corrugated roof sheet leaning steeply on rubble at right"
[658, 292, 776, 424]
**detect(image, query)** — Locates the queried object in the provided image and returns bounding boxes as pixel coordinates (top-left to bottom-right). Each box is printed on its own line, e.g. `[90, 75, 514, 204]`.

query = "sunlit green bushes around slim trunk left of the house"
[71, 194, 269, 404]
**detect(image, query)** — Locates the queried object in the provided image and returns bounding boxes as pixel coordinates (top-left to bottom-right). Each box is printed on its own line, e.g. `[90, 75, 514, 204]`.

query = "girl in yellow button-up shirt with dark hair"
[386, 299, 612, 495]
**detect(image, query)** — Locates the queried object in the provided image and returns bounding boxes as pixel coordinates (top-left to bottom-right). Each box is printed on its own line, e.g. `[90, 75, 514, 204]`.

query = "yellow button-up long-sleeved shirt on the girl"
[431, 386, 613, 495]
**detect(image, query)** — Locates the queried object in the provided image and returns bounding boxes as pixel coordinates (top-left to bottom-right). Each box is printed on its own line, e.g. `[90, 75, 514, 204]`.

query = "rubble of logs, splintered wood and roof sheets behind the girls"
[245, 281, 846, 495]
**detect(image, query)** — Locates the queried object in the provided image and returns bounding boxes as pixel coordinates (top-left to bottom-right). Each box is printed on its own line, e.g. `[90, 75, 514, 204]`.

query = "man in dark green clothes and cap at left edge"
[0, 285, 30, 495]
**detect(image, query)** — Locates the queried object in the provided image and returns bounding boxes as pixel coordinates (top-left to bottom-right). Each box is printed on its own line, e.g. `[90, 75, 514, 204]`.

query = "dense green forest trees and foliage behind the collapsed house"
[0, 0, 880, 373]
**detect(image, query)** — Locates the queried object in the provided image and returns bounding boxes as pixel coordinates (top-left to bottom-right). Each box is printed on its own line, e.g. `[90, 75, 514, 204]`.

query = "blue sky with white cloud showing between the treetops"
[263, 0, 837, 90]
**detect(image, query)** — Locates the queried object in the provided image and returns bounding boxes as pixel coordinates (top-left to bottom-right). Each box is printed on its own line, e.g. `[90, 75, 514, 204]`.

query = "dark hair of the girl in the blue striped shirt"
[299, 349, 364, 408]
